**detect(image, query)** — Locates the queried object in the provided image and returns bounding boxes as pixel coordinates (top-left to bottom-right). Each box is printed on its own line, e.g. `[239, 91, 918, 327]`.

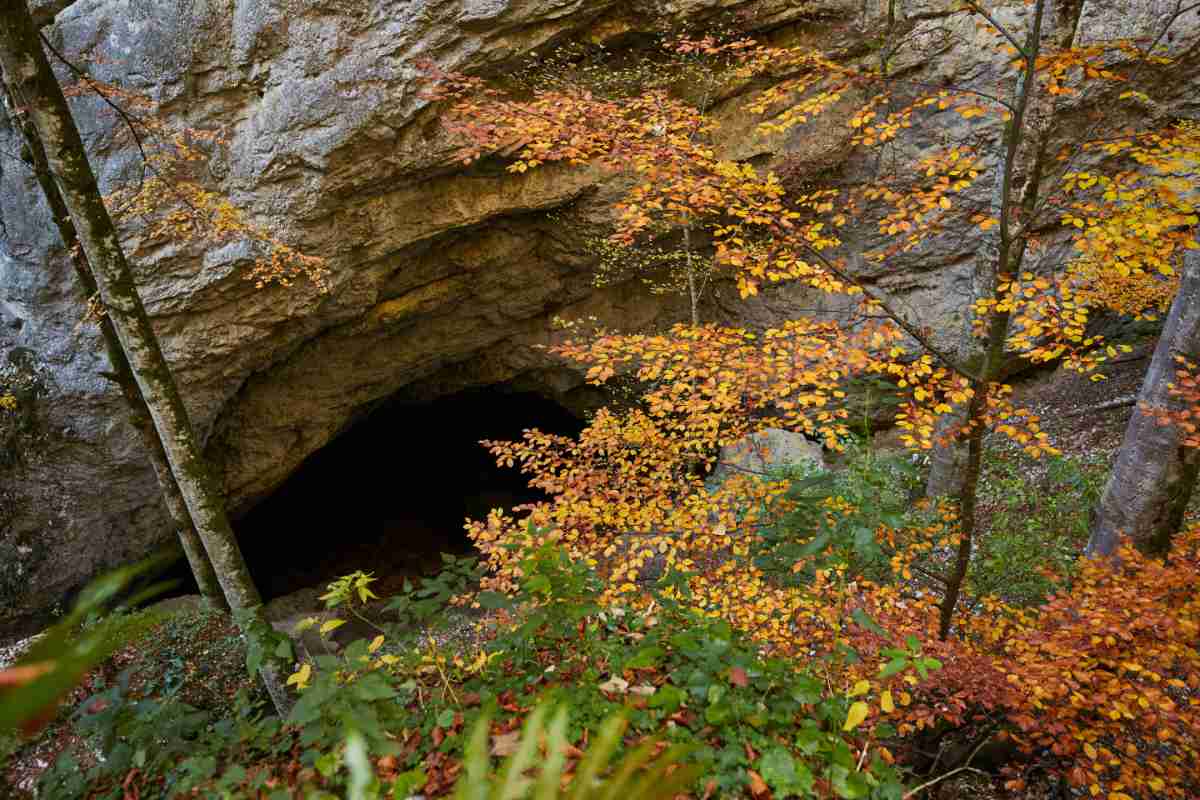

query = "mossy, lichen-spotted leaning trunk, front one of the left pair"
[0, 0, 289, 714]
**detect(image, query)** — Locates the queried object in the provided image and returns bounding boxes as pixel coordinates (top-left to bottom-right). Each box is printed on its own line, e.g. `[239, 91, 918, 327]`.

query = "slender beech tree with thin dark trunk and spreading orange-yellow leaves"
[430, 0, 1200, 637]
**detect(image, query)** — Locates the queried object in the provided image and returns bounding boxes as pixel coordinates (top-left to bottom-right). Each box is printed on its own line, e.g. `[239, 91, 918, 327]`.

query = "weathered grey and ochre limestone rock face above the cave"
[0, 0, 1200, 634]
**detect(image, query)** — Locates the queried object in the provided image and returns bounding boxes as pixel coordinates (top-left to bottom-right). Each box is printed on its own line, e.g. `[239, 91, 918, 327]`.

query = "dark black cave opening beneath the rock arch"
[234, 386, 583, 600]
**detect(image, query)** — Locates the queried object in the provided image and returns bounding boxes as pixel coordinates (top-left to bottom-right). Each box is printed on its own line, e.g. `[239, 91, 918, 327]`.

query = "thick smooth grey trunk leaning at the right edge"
[1087, 249, 1200, 557]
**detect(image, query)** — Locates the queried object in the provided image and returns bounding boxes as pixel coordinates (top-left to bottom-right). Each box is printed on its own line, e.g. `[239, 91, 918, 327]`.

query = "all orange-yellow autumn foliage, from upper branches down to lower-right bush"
[433, 28, 1200, 800]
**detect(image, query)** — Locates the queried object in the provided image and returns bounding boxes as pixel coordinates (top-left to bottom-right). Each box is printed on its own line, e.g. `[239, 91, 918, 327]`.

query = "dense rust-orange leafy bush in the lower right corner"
[997, 525, 1200, 800]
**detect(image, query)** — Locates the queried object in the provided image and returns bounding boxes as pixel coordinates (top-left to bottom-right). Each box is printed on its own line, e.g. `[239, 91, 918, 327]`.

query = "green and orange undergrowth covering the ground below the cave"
[9, 450, 1200, 800]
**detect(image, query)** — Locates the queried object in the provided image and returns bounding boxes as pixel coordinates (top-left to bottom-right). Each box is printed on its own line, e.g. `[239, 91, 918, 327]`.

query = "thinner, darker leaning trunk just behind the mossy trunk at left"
[0, 79, 228, 609]
